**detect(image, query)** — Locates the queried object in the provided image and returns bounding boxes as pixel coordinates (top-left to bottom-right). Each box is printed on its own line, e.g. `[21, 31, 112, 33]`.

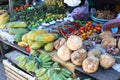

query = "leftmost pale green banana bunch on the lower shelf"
[17, 55, 28, 68]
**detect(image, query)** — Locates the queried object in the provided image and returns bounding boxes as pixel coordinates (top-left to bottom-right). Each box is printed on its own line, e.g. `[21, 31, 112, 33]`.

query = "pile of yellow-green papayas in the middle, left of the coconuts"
[17, 29, 58, 52]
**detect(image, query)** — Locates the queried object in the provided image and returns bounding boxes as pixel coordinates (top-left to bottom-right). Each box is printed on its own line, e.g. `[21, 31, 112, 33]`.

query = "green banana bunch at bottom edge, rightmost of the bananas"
[47, 63, 72, 80]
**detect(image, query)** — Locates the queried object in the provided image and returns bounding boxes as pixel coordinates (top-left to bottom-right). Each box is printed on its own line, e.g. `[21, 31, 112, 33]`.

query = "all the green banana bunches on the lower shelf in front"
[17, 51, 80, 80]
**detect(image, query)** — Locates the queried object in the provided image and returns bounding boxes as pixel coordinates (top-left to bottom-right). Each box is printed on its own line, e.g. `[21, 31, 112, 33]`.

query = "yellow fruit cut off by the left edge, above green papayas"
[0, 10, 9, 28]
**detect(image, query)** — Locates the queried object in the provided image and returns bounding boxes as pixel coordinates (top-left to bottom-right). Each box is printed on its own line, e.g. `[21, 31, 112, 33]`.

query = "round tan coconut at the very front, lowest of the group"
[82, 56, 99, 73]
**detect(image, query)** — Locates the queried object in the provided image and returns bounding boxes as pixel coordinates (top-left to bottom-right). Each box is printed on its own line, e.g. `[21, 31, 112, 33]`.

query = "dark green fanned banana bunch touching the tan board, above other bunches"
[39, 51, 53, 68]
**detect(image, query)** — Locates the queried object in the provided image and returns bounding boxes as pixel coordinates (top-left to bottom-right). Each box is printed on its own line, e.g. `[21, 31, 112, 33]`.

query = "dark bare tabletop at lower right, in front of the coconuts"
[76, 67, 120, 80]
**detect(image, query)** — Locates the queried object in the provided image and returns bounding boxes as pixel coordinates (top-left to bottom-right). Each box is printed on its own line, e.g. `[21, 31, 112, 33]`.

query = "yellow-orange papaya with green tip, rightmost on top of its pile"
[35, 33, 58, 43]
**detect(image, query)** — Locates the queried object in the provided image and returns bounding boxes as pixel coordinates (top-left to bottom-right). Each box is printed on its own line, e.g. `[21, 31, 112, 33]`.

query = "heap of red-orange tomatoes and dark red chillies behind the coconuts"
[58, 21, 101, 39]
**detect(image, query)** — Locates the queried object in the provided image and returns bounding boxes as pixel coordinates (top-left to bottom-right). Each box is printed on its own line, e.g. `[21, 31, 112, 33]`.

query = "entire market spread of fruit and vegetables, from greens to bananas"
[0, 3, 120, 80]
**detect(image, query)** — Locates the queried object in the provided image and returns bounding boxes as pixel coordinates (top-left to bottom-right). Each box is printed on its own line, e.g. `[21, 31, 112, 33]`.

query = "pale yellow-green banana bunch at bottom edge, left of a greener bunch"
[35, 68, 49, 80]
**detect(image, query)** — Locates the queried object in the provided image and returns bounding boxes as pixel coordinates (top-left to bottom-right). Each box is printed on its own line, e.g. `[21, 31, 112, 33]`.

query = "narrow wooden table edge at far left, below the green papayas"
[0, 38, 30, 55]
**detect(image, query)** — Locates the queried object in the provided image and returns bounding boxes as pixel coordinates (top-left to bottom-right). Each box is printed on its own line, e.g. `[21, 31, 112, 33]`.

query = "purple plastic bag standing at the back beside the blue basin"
[71, 0, 89, 20]
